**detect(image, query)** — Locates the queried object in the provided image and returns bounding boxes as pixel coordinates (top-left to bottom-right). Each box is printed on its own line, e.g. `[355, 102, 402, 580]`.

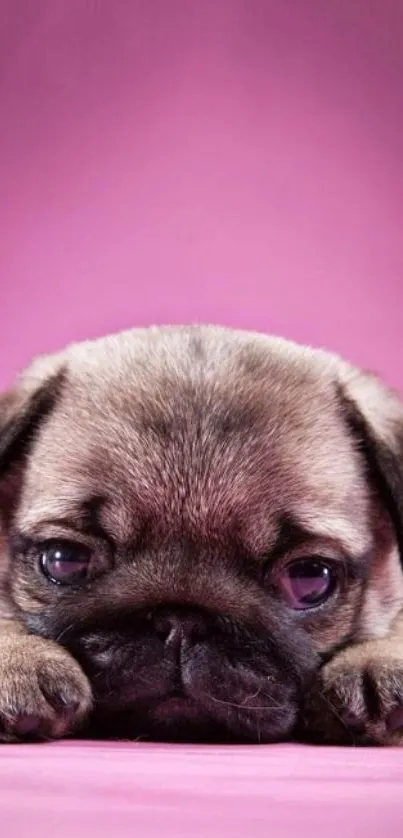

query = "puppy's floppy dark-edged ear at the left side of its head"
[0, 356, 65, 520]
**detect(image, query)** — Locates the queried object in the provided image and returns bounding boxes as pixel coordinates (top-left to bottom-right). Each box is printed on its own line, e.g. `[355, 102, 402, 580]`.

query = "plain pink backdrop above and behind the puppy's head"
[0, 0, 403, 385]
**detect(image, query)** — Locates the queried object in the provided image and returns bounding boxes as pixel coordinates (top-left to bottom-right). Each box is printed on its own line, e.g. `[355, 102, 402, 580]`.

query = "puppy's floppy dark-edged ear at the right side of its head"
[340, 365, 403, 564]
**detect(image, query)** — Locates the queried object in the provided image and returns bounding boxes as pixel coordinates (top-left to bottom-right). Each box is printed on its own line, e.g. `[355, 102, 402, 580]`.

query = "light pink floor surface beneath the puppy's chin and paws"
[0, 743, 403, 838]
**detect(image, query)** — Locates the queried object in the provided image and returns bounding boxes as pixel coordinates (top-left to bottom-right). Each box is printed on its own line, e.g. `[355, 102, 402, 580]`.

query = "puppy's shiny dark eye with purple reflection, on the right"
[280, 558, 338, 610]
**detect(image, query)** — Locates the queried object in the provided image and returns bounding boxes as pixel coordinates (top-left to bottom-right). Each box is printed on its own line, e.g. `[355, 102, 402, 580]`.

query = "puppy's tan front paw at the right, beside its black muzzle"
[302, 640, 403, 745]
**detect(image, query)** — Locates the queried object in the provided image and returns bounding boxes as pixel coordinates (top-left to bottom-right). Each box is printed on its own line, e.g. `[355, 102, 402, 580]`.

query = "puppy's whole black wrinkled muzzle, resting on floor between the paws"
[62, 612, 316, 742]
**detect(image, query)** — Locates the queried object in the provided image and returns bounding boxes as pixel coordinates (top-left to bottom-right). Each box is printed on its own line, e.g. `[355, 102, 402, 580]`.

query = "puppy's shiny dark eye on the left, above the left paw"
[40, 541, 90, 585]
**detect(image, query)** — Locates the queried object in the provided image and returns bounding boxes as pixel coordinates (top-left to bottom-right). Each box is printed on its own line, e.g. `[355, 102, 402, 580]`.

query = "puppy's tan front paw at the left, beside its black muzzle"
[0, 635, 92, 742]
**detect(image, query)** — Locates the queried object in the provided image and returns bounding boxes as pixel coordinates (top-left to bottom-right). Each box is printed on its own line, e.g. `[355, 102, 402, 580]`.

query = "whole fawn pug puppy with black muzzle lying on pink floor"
[0, 327, 403, 744]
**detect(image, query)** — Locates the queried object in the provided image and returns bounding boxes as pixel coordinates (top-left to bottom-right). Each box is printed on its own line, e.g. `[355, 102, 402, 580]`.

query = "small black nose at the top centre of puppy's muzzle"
[151, 608, 208, 645]
